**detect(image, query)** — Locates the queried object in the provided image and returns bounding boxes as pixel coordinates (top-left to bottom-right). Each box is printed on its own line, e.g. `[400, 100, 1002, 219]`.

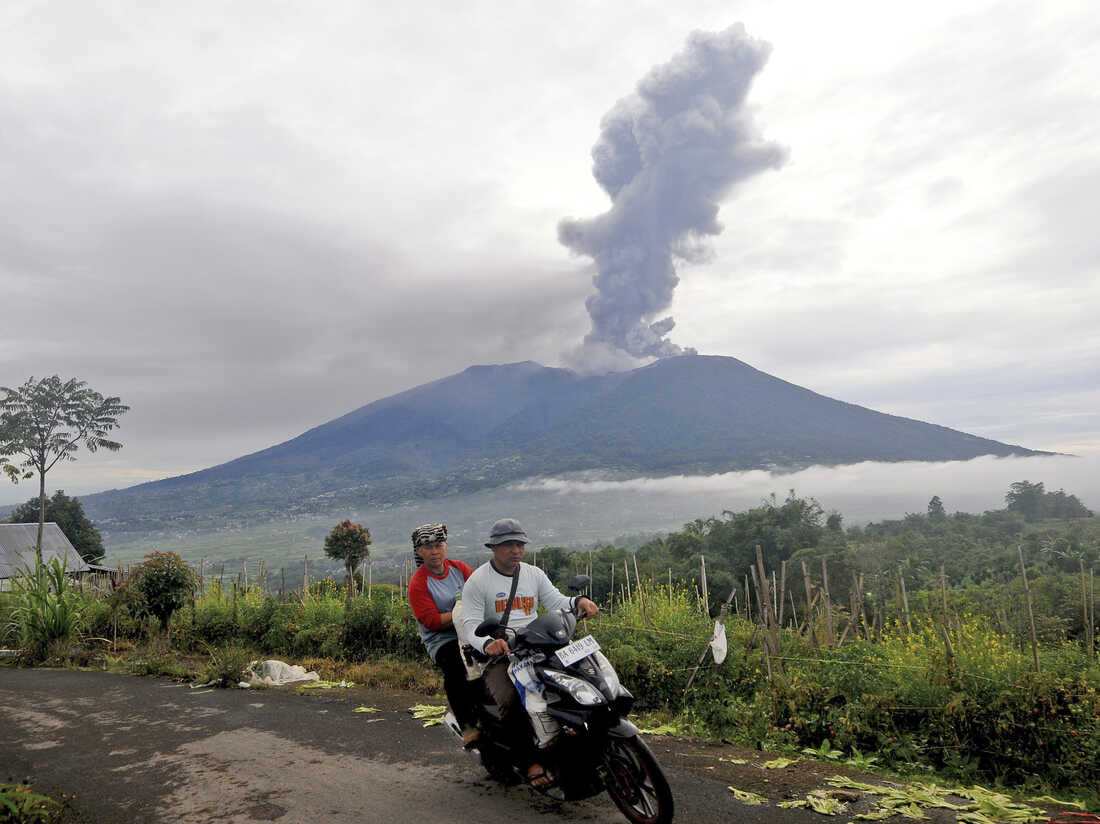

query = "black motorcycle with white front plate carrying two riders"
[444, 575, 673, 824]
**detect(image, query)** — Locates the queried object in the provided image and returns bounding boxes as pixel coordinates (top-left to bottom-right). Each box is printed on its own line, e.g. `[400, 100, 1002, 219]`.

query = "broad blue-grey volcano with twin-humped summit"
[83, 355, 1042, 531]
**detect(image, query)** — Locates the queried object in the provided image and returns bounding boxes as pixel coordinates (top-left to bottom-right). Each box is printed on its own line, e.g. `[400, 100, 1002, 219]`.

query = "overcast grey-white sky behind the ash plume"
[0, 0, 1100, 503]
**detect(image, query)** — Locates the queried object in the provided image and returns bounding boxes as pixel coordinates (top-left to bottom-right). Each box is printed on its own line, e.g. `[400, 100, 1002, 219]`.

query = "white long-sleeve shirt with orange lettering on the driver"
[462, 561, 576, 651]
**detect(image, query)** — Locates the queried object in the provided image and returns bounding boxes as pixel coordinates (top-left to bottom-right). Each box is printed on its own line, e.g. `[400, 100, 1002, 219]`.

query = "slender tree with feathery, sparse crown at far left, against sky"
[0, 375, 130, 565]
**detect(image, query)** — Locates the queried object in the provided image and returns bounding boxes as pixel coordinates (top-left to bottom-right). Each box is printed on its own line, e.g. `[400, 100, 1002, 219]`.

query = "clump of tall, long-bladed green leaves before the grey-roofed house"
[4, 558, 84, 662]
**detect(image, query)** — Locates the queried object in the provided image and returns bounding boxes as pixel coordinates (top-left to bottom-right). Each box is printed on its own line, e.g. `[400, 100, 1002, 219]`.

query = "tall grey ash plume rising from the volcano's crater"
[558, 23, 787, 361]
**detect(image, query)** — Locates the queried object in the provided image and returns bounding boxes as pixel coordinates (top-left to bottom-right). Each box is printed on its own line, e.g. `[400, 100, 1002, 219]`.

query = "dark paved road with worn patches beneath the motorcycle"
[0, 667, 815, 824]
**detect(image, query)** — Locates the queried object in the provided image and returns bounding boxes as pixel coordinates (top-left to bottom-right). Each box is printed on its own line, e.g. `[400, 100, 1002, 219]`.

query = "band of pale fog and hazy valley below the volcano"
[101, 454, 1100, 576]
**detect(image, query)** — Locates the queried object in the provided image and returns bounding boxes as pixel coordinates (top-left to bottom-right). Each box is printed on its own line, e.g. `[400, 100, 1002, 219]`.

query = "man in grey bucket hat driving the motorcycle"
[461, 518, 600, 788]
